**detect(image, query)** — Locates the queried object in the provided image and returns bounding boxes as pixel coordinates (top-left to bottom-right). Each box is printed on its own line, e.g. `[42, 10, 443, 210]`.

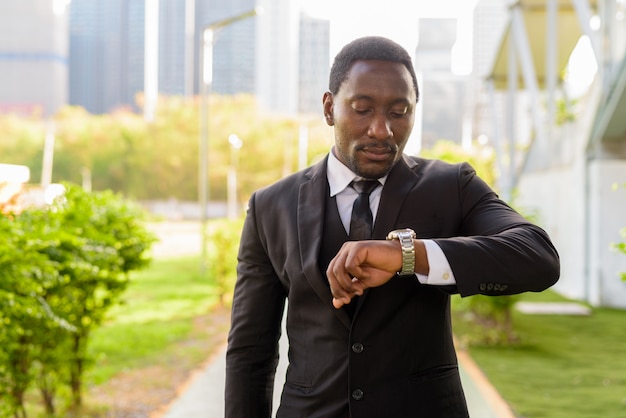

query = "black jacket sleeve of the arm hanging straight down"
[225, 195, 286, 418]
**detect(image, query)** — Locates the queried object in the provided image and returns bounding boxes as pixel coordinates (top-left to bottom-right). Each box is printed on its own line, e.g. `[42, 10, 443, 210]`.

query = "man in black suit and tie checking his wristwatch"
[226, 37, 559, 418]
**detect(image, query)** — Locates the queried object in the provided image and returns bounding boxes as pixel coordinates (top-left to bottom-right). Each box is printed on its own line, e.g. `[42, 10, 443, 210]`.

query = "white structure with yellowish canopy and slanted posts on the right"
[472, 0, 626, 308]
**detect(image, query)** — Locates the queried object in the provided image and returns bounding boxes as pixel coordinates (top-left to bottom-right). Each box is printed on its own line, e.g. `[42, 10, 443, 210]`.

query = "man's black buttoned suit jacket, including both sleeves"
[226, 156, 559, 418]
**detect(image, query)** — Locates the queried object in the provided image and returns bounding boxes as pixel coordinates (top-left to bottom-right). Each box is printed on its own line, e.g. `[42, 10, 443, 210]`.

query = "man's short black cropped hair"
[328, 36, 419, 102]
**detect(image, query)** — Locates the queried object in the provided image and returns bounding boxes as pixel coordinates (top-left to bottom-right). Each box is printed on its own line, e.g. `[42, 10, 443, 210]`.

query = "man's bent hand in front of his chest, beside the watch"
[326, 240, 402, 309]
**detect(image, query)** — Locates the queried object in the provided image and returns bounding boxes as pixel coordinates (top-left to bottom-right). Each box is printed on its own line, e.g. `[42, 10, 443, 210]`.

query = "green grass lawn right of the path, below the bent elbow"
[454, 292, 626, 418]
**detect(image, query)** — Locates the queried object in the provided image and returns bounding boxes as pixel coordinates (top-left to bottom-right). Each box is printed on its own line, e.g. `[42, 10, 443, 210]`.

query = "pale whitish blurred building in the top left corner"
[0, 0, 68, 116]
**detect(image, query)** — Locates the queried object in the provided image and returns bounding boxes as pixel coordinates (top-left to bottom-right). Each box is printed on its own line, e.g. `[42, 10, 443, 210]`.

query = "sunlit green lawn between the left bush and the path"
[86, 257, 227, 384]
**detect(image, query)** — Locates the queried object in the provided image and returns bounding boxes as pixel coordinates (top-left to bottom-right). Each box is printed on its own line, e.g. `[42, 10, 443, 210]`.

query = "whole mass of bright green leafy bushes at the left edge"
[0, 184, 154, 416]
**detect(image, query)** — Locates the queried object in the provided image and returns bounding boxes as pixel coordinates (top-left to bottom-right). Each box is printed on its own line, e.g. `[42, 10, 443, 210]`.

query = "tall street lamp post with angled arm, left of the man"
[198, 7, 261, 273]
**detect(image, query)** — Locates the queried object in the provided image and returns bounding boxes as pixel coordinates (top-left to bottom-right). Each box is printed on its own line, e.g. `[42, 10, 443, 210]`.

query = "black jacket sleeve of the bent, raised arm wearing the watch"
[435, 164, 560, 296]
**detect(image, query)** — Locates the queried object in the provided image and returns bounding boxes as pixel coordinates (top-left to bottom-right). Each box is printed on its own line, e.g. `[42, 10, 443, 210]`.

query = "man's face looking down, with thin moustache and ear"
[324, 60, 416, 179]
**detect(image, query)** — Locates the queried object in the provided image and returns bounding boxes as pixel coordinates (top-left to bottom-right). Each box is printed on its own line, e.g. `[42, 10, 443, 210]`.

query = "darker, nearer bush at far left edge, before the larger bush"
[0, 206, 64, 416]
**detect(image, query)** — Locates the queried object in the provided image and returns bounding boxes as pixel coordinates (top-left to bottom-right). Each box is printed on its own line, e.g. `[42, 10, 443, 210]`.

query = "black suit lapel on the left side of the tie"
[298, 159, 351, 328]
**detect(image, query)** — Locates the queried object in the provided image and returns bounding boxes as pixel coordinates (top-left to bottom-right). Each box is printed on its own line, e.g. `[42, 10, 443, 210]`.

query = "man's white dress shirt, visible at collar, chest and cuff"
[328, 150, 456, 285]
